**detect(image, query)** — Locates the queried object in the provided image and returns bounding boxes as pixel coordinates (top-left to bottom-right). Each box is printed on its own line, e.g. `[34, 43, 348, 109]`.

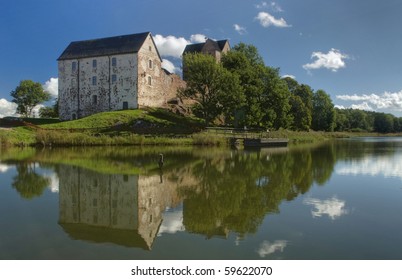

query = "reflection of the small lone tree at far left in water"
[12, 162, 50, 199]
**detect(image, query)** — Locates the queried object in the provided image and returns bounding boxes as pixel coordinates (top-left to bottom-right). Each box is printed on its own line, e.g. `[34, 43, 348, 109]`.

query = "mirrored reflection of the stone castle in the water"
[58, 165, 181, 249]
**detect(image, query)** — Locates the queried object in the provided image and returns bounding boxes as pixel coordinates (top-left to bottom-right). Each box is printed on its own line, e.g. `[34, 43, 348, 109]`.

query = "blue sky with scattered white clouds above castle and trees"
[0, 0, 402, 117]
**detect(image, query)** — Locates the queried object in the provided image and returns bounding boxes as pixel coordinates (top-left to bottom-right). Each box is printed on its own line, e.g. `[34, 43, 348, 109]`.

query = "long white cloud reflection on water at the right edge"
[335, 153, 402, 180]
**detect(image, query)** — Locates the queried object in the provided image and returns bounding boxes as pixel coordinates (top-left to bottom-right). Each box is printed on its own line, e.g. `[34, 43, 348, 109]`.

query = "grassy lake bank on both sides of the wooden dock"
[0, 109, 396, 149]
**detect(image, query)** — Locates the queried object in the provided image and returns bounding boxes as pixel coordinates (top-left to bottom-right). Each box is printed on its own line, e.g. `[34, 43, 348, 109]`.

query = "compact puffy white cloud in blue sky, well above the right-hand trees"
[303, 48, 349, 72]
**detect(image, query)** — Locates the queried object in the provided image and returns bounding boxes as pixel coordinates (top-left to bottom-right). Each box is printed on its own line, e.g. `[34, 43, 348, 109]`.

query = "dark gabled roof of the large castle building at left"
[58, 32, 150, 60]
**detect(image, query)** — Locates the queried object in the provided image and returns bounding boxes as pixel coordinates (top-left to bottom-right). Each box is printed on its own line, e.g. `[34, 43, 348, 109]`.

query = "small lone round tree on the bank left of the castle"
[10, 80, 50, 117]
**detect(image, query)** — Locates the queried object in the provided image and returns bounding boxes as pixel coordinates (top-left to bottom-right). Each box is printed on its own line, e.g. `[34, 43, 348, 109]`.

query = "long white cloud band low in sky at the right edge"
[336, 90, 402, 111]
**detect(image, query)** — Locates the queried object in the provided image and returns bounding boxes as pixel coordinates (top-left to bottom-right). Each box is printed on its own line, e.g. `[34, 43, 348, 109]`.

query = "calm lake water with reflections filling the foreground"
[0, 138, 402, 260]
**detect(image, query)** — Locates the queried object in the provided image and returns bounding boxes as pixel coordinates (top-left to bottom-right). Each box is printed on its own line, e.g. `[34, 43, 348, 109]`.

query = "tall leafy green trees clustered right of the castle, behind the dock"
[181, 43, 335, 131]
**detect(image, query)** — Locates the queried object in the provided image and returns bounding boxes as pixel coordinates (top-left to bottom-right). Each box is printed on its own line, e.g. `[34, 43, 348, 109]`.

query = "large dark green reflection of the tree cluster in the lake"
[183, 145, 335, 237]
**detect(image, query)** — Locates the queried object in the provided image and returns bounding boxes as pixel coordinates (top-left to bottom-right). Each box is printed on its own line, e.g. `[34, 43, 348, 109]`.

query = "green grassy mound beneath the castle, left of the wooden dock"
[0, 108, 223, 146]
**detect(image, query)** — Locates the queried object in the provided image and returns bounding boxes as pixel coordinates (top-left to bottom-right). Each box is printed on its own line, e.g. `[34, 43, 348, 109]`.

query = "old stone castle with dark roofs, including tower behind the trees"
[58, 32, 230, 120]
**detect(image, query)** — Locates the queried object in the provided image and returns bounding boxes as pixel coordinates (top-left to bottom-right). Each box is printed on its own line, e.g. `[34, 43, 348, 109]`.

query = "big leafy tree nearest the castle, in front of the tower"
[180, 53, 244, 125]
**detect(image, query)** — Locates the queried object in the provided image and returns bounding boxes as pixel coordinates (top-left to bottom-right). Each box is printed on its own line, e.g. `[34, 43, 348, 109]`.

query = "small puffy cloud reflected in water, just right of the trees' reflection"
[303, 197, 348, 220]
